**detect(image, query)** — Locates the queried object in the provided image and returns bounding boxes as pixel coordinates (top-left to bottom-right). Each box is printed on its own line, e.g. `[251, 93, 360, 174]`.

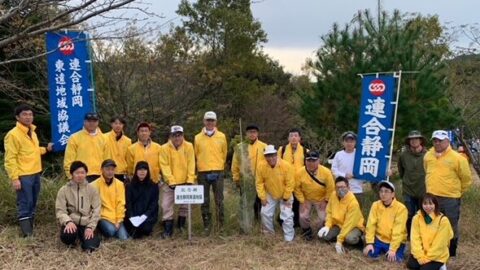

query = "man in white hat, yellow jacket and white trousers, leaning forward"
[256, 145, 295, 242]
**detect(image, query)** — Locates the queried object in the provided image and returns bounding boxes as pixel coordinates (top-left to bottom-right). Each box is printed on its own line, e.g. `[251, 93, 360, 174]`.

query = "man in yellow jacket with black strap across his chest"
[295, 151, 335, 241]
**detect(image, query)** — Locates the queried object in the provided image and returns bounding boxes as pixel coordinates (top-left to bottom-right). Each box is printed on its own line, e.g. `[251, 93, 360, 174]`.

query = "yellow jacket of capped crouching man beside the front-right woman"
[365, 199, 408, 252]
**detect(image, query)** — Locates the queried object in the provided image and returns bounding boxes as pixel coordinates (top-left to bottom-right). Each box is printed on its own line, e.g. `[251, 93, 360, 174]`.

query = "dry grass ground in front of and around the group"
[0, 170, 480, 270]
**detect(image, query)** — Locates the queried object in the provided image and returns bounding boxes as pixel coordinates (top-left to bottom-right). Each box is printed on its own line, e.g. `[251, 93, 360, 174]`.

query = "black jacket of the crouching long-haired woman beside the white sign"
[125, 181, 159, 229]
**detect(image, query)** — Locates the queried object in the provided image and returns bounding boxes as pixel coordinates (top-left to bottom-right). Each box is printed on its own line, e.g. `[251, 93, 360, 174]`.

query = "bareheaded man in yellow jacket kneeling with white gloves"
[318, 176, 365, 254]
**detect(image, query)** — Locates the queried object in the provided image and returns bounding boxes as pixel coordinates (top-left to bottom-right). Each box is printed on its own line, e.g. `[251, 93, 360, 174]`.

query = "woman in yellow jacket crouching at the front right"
[407, 193, 453, 270]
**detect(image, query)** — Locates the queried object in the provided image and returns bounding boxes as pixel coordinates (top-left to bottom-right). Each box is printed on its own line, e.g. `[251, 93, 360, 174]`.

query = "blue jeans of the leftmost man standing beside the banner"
[17, 173, 40, 220]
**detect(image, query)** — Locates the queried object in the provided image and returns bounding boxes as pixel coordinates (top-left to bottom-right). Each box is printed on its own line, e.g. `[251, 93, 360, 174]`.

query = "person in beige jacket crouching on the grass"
[55, 161, 101, 252]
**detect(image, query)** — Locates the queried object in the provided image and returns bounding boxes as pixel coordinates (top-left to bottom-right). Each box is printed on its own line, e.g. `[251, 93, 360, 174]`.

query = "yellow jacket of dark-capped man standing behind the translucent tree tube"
[232, 140, 267, 182]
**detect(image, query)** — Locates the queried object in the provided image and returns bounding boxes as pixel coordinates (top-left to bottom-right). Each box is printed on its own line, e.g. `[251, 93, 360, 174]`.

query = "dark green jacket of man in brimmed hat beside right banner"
[398, 146, 427, 198]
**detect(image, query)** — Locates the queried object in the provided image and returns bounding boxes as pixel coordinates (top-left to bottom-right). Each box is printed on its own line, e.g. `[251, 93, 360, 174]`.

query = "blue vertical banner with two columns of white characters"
[46, 31, 95, 151]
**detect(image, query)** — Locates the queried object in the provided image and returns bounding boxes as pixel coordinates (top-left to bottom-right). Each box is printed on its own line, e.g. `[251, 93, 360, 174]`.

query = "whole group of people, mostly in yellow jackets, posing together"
[5, 105, 472, 269]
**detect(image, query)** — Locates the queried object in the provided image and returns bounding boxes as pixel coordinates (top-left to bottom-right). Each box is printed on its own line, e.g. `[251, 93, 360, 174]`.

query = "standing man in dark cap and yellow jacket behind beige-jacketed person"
[63, 113, 107, 183]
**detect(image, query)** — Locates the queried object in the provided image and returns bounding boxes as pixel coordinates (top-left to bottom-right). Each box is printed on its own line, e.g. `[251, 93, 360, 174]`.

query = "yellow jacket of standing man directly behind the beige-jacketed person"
[63, 129, 107, 179]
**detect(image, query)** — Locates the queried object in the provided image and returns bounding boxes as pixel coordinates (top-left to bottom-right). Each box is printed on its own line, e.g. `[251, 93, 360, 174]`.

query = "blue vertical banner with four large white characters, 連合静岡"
[353, 75, 397, 183]
